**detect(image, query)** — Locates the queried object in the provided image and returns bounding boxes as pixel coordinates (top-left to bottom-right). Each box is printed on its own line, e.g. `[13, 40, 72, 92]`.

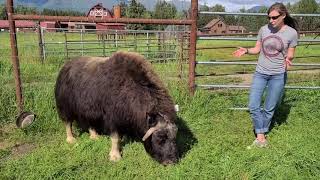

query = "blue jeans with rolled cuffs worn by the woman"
[249, 72, 287, 134]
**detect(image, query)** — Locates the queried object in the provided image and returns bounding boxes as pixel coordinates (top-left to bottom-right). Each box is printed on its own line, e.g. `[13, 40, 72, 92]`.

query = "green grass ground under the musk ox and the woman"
[0, 33, 320, 179]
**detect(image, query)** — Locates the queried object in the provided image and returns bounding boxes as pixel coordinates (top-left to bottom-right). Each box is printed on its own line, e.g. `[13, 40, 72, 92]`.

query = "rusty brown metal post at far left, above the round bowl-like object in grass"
[7, 0, 23, 113]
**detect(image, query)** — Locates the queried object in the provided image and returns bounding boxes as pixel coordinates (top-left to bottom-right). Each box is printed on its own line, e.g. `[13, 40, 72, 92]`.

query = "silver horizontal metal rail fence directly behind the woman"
[191, 12, 320, 95]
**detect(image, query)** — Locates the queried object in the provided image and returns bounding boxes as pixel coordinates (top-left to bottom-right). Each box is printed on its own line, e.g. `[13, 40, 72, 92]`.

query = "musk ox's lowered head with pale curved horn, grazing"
[142, 113, 178, 165]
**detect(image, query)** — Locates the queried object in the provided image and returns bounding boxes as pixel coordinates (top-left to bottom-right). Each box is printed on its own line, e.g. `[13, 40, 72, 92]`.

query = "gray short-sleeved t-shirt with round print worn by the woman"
[256, 24, 298, 75]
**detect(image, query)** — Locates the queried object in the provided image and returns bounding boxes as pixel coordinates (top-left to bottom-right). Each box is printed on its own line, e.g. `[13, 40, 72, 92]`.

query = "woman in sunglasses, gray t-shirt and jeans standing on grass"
[233, 3, 298, 148]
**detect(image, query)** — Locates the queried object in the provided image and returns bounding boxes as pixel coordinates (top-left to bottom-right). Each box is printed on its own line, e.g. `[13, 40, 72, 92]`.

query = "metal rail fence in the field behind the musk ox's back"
[39, 26, 190, 62]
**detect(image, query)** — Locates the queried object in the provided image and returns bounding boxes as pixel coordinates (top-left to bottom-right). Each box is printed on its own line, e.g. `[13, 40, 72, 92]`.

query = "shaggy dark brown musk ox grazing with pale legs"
[55, 52, 178, 165]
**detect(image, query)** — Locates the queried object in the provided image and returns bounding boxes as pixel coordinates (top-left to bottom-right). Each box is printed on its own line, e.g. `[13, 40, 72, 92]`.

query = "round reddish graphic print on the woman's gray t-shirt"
[262, 35, 284, 57]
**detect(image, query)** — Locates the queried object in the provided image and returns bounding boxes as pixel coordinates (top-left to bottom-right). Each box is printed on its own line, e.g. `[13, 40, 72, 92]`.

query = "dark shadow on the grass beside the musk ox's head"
[176, 117, 198, 159]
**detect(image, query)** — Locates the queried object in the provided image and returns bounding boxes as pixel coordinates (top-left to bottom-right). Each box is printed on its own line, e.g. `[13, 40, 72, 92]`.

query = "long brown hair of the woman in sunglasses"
[268, 3, 299, 31]
